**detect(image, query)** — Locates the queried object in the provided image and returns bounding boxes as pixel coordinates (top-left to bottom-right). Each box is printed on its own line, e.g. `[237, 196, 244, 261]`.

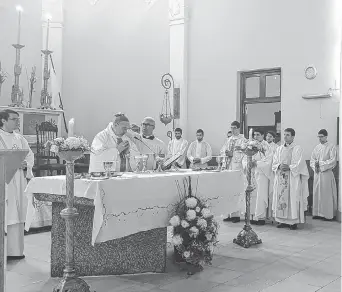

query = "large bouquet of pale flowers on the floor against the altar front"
[169, 177, 218, 267]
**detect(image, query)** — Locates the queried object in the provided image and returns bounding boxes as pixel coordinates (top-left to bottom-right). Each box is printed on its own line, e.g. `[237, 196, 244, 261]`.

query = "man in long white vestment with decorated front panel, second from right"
[272, 128, 309, 230]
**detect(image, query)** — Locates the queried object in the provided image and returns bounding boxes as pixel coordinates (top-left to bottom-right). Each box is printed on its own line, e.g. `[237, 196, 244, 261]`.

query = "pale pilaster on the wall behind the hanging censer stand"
[169, 0, 188, 138]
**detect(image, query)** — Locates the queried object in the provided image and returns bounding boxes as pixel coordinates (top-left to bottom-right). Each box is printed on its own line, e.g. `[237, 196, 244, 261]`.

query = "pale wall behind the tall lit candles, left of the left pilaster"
[0, 0, 42, 107]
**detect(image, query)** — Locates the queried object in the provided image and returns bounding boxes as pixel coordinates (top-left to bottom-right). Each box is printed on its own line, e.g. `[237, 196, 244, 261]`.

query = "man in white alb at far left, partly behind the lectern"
[0, 110, 34, 260]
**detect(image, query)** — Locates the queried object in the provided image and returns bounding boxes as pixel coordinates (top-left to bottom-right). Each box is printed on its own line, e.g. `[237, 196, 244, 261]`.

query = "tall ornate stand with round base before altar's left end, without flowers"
[53, 151, 90, 292]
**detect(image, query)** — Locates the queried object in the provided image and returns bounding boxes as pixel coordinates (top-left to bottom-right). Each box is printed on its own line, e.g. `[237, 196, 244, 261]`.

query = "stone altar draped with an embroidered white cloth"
[25, 171, 243, 277]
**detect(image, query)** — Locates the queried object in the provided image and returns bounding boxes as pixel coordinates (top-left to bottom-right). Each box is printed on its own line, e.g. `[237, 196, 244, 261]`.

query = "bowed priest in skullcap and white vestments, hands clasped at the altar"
[89, 113, 138, 173]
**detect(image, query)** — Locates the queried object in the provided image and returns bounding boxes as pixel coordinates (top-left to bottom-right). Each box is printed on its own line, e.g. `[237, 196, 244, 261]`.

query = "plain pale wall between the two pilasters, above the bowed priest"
[62, 0, 169, 141]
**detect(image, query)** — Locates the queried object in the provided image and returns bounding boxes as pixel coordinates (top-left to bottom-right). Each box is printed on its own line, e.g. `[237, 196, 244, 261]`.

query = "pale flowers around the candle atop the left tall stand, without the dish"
[44, 137, 90, 155]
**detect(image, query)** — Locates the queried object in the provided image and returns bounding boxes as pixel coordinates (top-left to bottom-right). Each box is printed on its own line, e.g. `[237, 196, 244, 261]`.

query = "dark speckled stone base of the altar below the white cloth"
[51, 202, 167, 277]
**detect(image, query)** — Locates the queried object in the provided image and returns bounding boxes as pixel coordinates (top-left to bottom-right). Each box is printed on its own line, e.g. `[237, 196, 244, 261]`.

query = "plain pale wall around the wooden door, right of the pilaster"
[188, 0, 341, 159]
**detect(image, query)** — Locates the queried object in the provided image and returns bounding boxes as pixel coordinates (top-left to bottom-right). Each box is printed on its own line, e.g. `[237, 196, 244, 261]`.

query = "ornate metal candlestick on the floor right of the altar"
[233, 151, 262, 248]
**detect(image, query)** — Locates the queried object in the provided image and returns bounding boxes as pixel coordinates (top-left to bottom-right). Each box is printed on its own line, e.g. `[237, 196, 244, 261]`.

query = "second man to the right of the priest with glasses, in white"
[187, 129, 212, 169]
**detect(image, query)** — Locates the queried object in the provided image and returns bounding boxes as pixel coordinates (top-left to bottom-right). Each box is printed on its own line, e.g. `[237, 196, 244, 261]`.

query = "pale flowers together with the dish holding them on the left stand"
[44, 137, 90, 160]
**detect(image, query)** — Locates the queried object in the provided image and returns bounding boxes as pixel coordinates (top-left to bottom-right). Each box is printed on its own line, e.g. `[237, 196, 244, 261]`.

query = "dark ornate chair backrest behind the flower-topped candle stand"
[36, 121, 58, 159]
